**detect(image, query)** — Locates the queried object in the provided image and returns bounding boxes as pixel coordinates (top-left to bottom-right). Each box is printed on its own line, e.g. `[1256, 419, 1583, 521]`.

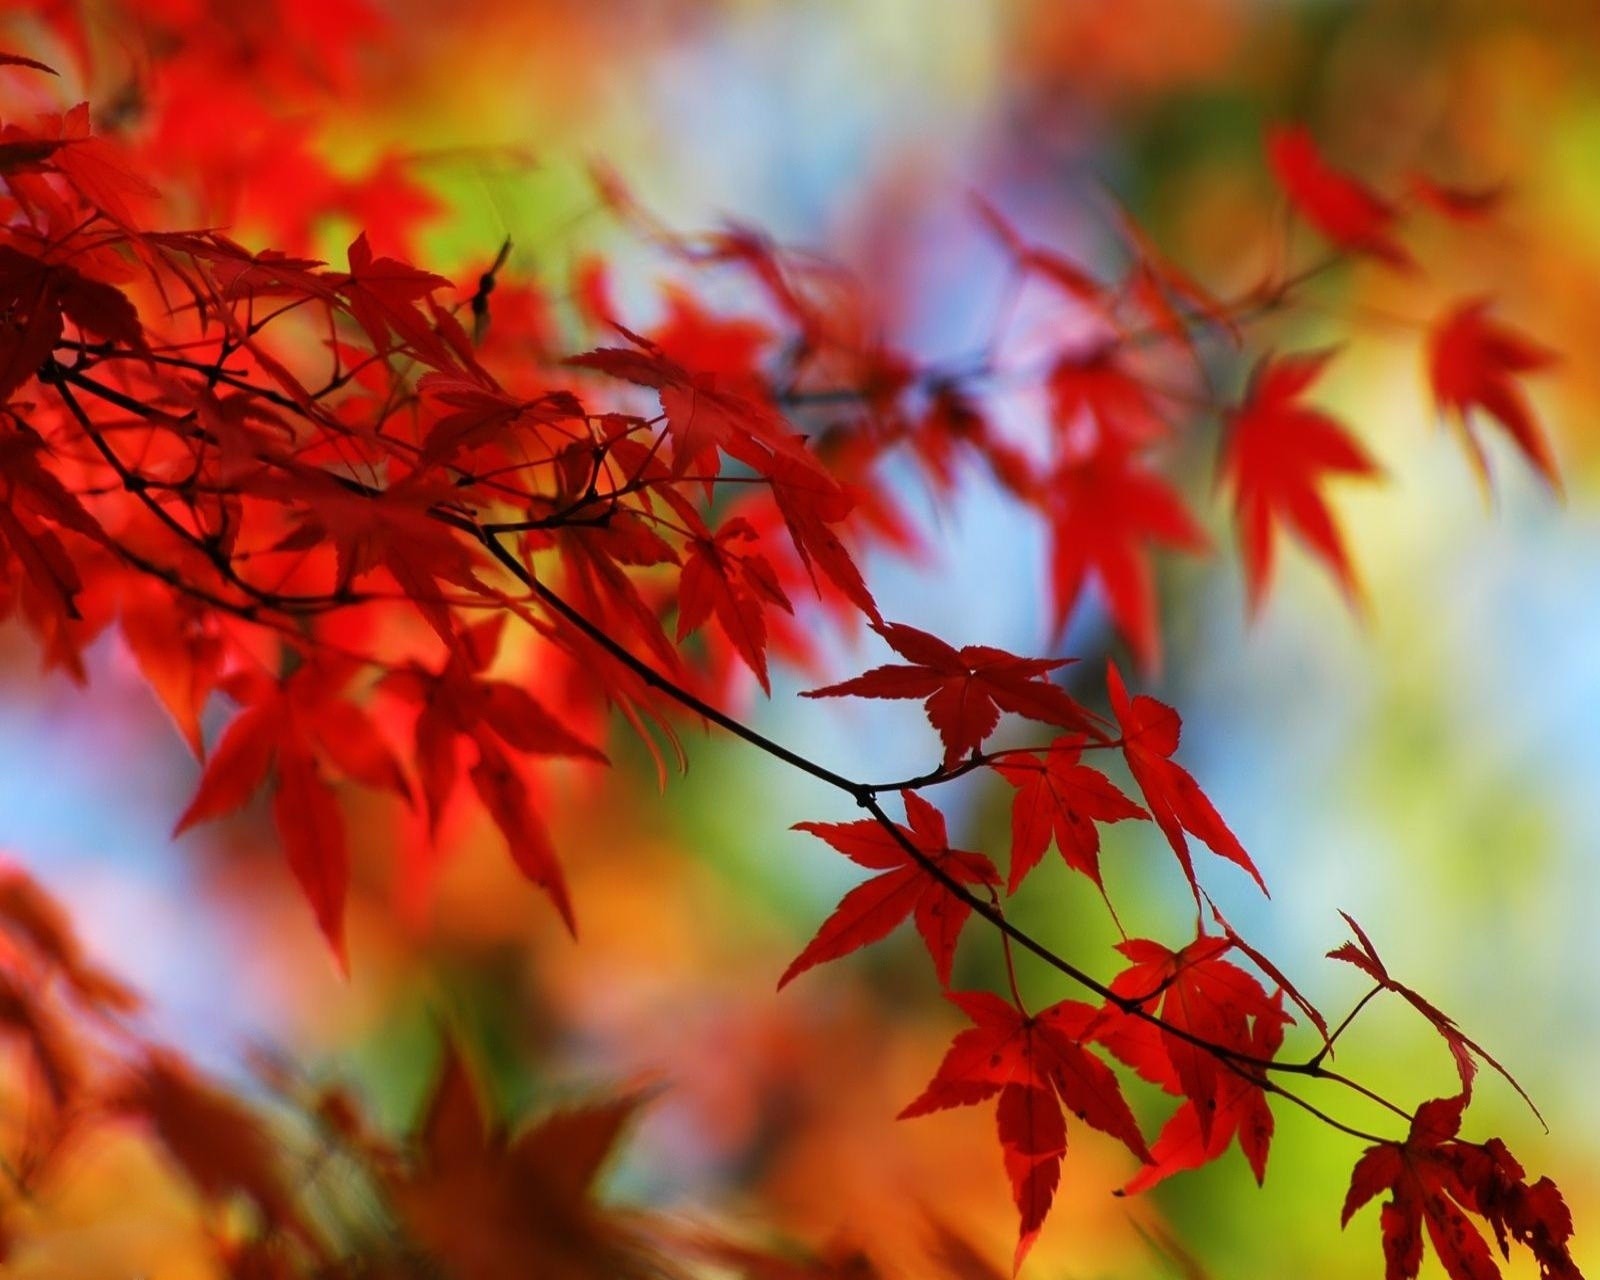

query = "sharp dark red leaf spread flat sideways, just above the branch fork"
[800, 622, 1101, 768]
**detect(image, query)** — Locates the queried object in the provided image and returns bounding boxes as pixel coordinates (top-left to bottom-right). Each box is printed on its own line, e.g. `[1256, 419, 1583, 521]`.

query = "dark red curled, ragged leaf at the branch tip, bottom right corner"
[1339, 1093, 1581, 1280]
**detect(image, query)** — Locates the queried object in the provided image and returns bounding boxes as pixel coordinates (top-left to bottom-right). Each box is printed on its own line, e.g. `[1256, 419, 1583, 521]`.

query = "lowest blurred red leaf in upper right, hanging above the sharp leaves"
[1045, 448, 1211, 669]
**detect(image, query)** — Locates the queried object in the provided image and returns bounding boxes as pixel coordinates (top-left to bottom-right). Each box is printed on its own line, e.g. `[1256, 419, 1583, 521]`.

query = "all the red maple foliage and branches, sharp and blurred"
[0, 0, 1578, 1280]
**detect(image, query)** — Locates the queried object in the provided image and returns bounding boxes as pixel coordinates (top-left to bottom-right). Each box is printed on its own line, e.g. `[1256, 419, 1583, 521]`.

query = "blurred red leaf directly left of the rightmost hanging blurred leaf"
[1221, 350, 1378, 610]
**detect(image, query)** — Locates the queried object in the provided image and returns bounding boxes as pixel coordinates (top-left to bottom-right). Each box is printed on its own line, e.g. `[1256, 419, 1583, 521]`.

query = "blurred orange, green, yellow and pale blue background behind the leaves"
[0, 0, 1600, 1280]
